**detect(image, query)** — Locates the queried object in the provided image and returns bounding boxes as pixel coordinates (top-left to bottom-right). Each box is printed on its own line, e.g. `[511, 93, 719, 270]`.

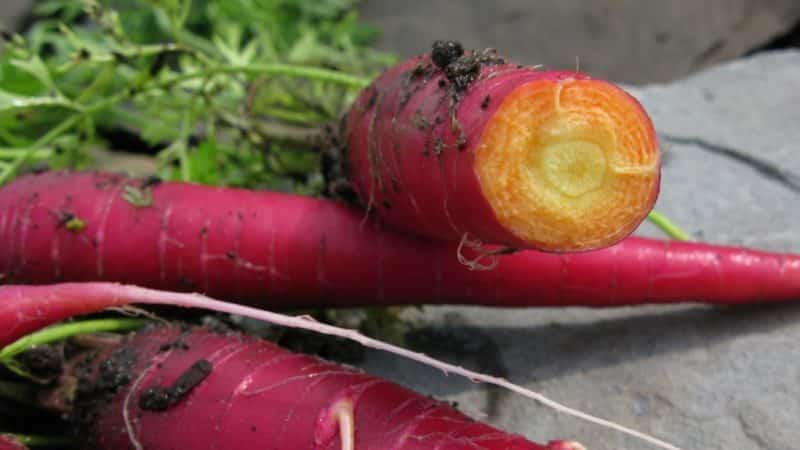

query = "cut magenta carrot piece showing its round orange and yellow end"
[342, 41, 660, 252]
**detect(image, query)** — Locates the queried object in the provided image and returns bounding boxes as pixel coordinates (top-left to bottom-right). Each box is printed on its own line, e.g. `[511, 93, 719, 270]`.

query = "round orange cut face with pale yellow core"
[475, 78, 660, 251]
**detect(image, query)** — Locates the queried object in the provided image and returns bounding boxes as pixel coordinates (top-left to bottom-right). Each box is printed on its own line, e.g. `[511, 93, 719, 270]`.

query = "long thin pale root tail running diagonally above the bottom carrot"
[117, 283, 681, 450]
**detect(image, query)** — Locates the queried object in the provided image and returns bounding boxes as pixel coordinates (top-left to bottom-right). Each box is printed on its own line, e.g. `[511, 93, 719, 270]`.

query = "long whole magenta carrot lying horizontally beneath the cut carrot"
[0, 173, 800, 309]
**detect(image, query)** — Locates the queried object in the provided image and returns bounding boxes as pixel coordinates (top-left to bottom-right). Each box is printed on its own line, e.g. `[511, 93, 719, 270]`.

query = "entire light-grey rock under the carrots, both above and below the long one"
[358, 52, 800, 450]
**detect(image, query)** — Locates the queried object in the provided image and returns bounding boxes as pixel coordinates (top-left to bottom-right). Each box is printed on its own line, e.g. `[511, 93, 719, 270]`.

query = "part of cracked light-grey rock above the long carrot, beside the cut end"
[632, 51, 800, 252]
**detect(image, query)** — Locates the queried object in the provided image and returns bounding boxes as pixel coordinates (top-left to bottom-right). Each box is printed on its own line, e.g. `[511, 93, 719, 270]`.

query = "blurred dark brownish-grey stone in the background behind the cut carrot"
[362, 0, 800, 83]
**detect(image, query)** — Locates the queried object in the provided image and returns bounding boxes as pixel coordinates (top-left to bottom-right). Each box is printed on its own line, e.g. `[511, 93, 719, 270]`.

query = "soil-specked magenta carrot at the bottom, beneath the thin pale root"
[75, 327, 582, 450]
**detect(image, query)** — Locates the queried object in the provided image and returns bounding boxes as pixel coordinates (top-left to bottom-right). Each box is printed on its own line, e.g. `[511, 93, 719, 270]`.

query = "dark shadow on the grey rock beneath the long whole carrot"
[367, 304, 800, 418]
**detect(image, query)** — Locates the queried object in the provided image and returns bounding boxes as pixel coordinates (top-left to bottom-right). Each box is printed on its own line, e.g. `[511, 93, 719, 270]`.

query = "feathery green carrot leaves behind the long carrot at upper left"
[0, 0, 393, 189]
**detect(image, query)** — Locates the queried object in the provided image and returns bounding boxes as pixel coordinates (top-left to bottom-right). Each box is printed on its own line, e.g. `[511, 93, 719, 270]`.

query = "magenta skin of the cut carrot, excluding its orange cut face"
[345, 55, 586, 248]
